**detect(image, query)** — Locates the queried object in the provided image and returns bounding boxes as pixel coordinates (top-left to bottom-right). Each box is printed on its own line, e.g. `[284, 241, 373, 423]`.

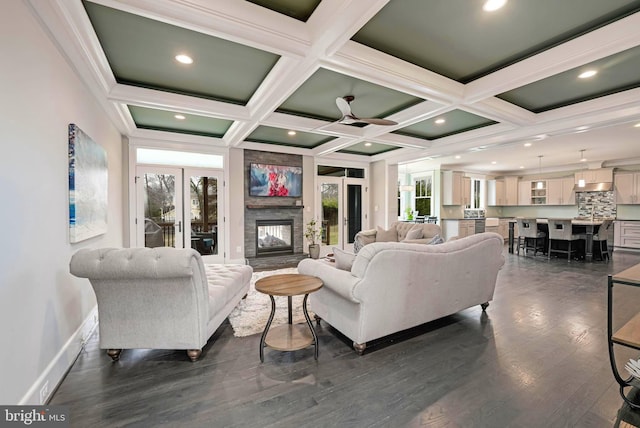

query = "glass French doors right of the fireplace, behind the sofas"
[318, 176, 368, 255]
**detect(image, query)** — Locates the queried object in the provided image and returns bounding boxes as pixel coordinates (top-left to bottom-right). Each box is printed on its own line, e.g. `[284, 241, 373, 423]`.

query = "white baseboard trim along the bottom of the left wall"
[18, 305, 98, 405]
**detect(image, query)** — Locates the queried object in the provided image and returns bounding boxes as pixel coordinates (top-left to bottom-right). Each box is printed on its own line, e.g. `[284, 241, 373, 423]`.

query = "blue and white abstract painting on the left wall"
[69, 123, 108, 243]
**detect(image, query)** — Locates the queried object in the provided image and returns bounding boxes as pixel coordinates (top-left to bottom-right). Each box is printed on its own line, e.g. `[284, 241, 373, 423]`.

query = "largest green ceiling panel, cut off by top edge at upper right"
[352, 0, 640, 83]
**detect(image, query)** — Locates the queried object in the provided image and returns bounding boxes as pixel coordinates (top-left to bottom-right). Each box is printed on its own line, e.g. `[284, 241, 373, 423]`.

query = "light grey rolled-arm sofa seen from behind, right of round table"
[298, 232, 504, 354]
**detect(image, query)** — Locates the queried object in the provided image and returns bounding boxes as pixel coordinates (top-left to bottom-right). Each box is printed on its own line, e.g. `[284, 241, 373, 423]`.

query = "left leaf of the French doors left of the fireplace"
[135, 166, 184, 248]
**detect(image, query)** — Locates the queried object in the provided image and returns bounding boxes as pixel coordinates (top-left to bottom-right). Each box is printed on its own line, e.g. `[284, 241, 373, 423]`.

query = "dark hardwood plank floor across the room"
[50, 247, 640, 428]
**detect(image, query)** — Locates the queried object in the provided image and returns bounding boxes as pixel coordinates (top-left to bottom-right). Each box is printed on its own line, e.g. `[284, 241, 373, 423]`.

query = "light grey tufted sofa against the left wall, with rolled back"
[70, 247, 253, 361]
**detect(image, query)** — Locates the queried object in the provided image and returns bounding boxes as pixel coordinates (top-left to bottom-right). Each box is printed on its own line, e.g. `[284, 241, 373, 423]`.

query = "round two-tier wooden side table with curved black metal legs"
[256, 273, 322, 362]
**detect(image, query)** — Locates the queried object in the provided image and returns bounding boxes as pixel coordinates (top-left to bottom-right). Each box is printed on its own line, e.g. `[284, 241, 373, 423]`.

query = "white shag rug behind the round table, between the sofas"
[229, 268, 313, 337]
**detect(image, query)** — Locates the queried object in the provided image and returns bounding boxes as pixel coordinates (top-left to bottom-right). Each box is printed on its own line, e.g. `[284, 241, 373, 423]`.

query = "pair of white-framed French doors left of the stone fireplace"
[136, 165, 224, 263]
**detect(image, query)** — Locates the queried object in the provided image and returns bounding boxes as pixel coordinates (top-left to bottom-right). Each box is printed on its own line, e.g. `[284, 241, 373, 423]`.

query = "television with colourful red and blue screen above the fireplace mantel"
[249, 163, 302, 198]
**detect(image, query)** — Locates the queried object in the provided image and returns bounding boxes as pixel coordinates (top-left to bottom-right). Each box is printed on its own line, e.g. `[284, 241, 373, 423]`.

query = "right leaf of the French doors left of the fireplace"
[184, 168, 224, 263]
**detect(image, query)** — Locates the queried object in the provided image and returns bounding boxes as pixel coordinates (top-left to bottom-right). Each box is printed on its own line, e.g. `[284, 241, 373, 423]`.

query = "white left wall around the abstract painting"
[0, 1, 124, 404]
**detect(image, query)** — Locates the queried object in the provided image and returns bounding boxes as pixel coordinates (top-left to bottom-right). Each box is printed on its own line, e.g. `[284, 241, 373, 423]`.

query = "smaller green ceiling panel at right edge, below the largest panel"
[498, 47, 640, 113]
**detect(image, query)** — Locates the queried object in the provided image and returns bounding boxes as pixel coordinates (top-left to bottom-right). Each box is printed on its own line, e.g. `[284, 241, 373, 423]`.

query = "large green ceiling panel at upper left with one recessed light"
[83, 1, 279, 104]
